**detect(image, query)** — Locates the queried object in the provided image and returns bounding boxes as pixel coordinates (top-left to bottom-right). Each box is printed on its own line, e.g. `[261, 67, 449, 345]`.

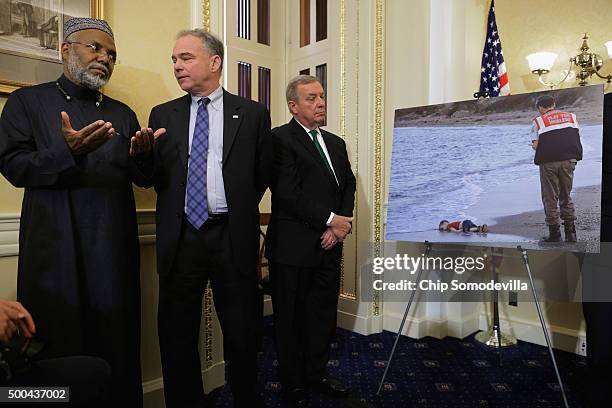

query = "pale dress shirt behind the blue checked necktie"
[185, 86, 227, 214]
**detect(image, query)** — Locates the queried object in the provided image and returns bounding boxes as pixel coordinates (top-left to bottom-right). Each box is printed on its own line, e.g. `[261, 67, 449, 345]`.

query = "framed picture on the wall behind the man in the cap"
[0, 0, 103, 94]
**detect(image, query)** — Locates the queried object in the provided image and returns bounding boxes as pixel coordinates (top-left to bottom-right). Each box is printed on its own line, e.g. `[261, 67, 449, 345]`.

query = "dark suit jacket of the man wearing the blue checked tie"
[149, 90, 272, 276]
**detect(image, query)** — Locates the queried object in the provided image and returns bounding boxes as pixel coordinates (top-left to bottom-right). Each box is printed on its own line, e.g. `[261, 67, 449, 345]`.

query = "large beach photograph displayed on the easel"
[386, 85, 603, 252]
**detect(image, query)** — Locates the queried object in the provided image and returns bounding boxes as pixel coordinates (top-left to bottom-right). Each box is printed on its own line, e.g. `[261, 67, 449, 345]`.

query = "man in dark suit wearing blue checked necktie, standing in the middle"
[135, 30, 271, 408]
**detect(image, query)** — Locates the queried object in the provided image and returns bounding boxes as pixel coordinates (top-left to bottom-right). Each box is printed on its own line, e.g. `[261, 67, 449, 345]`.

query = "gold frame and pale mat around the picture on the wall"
[0, 0, 104, 95]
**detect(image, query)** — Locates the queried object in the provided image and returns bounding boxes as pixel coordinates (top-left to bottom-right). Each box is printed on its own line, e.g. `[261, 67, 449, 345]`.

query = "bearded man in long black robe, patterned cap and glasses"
[0, 18, 158, 407]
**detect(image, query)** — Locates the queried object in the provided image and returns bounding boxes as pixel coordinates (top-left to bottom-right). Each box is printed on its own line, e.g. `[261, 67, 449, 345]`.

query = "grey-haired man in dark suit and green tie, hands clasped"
[267, 75, 356, 406]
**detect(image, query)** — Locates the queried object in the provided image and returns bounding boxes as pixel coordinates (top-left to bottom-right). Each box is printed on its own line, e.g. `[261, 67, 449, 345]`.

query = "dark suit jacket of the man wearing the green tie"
[267, 119, 356, 267]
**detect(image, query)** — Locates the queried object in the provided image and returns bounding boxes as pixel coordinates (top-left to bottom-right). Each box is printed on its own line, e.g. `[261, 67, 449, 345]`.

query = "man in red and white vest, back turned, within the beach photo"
[531, 95, 582, 242]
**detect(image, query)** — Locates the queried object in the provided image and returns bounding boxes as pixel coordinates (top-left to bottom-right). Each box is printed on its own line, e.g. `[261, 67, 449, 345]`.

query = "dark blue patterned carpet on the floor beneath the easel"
[215, 318, 586, 408]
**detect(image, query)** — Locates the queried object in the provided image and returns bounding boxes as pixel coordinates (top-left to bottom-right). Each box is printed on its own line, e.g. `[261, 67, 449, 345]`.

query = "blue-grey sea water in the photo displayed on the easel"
[386, 124, 603, 242]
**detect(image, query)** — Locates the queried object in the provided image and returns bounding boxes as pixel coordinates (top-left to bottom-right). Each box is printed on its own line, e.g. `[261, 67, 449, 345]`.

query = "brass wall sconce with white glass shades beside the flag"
[526, 33, 612, 88]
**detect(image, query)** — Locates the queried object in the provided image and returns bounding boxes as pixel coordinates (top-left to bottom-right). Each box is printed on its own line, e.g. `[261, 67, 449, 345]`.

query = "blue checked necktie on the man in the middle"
[185, 98, 210, 229]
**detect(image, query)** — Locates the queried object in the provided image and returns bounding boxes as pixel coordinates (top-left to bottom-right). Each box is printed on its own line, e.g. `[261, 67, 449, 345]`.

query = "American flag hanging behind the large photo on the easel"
[480, 0, 510, 96]
